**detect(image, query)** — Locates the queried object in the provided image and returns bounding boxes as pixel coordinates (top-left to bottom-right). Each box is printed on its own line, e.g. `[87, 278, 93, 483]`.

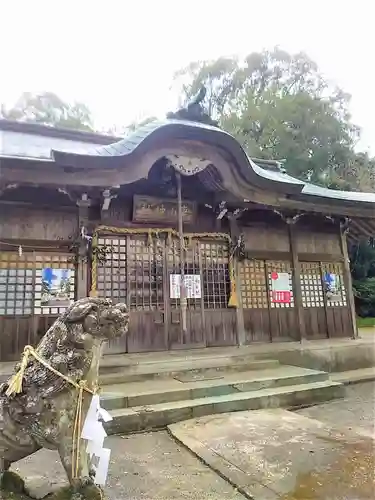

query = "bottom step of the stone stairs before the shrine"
[106, 380, 344, 434]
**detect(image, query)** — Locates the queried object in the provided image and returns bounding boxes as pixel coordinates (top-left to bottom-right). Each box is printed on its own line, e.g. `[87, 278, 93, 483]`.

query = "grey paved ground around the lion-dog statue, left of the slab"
[13, 432, 244, 500]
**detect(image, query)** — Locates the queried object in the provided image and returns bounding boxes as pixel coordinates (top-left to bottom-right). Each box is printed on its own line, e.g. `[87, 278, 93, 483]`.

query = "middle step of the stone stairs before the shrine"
[102, 366, 328, 410]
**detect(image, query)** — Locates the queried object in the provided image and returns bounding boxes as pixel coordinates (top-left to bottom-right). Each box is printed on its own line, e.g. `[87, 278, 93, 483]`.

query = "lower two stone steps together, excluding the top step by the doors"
[101, 361, 344, 434]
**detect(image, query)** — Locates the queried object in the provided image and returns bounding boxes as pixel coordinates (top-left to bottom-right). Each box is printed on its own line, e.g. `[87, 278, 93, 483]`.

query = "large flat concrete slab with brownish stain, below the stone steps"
[168, 409, 375, 500]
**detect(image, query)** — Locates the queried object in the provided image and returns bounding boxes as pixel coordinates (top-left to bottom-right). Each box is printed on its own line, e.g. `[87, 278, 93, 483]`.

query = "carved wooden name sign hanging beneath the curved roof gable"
[133, 195, 196, 224]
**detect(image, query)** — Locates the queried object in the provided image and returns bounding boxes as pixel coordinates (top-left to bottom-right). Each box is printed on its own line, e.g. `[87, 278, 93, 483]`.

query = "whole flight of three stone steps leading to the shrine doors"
[101, 348, 343, 434]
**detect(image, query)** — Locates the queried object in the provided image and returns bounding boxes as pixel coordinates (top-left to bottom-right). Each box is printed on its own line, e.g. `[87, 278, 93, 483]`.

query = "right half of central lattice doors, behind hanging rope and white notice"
[167, 239, 237, 349]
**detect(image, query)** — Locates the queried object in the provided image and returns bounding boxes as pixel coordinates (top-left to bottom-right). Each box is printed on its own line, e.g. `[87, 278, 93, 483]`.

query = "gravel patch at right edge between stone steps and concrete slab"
[297, 382, 375, 438]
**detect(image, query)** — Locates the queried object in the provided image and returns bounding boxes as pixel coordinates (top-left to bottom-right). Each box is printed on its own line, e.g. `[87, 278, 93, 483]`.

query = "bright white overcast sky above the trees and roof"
[0, 0, 375, 154]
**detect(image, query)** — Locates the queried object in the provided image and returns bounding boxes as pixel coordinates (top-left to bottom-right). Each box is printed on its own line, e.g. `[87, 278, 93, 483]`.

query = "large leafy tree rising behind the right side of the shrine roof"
[175, 48, 374, 189]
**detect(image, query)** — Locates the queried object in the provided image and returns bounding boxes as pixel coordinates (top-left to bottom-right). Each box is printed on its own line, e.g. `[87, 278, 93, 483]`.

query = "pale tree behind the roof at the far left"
[0, 92, 93, 131]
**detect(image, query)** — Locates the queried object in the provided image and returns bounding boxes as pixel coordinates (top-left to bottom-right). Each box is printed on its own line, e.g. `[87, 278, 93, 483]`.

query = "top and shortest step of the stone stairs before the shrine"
[99, 356, 280, 386]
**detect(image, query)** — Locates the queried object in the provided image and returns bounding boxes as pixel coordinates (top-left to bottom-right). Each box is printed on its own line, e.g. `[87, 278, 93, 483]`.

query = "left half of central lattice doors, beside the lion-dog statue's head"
[97, 234, 168, 353]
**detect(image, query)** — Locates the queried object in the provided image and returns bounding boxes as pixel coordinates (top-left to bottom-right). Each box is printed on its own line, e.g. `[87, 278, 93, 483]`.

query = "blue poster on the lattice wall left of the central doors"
[41, 267, 71, 307]
